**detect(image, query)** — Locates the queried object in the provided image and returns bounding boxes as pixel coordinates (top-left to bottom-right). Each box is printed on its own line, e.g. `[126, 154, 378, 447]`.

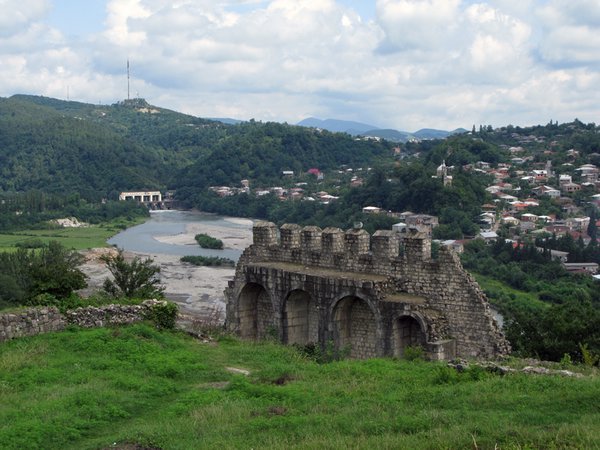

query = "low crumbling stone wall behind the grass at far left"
[0, 300, 166, 342]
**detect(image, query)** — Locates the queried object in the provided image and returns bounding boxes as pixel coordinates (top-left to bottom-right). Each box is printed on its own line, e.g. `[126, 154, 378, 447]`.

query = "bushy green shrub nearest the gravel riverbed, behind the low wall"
[102, 249, 164, 299]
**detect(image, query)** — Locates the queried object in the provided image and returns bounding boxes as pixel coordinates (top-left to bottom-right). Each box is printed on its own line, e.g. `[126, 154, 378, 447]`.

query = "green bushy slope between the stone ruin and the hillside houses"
[462, 239, 600, 362]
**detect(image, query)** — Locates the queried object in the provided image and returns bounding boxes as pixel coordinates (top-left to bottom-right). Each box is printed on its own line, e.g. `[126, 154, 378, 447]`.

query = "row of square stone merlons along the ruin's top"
[253, 221, 431, 274]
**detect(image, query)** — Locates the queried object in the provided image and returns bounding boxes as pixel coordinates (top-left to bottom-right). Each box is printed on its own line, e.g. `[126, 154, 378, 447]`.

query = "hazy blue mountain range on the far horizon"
[298, 117, 467, 142]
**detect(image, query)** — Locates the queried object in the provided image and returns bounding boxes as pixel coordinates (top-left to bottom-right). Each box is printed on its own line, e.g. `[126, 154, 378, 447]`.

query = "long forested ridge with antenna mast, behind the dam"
[0, 95, 391, 200]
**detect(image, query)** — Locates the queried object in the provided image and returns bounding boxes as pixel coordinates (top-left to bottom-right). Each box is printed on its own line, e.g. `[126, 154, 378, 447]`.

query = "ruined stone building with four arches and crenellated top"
[225, 222, 510, 360]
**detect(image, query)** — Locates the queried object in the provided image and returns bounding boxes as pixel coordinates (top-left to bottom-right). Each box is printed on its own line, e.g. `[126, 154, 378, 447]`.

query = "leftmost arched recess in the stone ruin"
[238, 283, 275, 339]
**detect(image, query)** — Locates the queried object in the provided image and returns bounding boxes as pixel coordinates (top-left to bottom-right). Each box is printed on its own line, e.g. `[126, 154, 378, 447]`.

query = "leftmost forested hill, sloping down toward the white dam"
[0, 98, 169, 198]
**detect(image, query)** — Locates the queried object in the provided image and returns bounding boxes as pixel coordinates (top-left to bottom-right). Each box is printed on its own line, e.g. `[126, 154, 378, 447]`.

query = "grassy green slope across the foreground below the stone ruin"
[0, 324, 600, 449]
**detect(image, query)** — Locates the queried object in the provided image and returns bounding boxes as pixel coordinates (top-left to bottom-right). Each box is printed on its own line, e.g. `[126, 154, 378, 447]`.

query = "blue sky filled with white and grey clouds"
[0, 0, 600, 131]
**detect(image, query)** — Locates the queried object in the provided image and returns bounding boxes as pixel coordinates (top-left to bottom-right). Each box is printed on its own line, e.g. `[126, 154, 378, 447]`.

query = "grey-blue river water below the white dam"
[108, 210, 247, 261]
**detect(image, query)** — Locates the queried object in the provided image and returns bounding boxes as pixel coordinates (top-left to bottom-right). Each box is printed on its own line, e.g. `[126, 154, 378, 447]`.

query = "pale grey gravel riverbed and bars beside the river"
[82, 214, 252, 320]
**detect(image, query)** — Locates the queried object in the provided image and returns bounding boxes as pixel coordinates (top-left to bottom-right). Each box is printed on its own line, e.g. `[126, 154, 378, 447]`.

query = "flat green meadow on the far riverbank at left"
[0, 218, 146, 251]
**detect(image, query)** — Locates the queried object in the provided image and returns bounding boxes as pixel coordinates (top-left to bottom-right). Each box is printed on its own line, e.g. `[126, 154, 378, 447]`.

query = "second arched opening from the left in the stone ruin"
[283, 290, 318, 345]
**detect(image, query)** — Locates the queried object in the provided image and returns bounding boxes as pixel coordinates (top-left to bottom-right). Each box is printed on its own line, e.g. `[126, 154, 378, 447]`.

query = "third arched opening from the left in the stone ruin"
[333, 296, 377, 358]
